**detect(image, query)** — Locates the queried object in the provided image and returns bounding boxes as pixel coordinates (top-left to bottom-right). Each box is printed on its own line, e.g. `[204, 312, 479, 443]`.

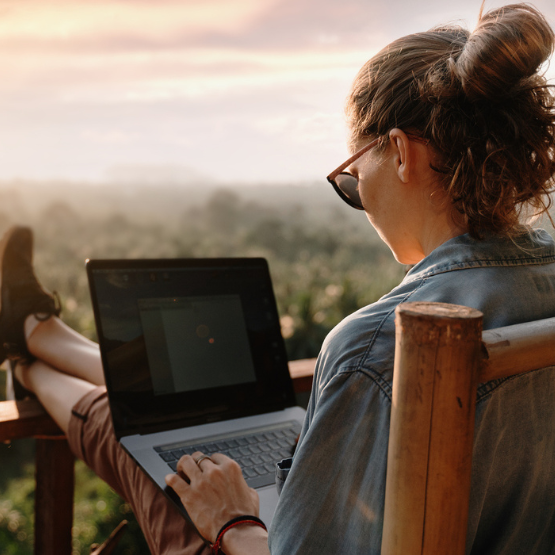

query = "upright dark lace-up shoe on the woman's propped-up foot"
[0, 226, 60, 363]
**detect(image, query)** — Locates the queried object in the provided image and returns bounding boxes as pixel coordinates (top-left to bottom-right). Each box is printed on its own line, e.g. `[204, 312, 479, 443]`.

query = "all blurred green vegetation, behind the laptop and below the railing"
[0, 181, 432, 555]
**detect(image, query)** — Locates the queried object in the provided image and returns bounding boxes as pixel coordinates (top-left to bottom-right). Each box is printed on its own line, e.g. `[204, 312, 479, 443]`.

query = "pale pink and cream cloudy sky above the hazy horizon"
[0, 0, 555, 184]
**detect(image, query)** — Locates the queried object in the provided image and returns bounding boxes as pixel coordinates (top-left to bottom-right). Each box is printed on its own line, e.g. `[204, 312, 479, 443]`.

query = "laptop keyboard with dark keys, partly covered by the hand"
[154, 422, 300, 488]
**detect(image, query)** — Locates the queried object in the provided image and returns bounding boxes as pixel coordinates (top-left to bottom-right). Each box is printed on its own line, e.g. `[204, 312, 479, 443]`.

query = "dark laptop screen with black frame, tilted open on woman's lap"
[87, 258, 294, 437]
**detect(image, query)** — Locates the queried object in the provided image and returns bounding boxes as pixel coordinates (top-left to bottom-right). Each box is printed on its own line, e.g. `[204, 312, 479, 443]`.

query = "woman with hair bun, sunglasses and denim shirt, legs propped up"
[6, 4, 555, 555]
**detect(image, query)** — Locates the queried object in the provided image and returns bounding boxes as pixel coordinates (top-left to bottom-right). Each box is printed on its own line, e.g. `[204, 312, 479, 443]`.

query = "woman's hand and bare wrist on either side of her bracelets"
[166, 452, 270, 555]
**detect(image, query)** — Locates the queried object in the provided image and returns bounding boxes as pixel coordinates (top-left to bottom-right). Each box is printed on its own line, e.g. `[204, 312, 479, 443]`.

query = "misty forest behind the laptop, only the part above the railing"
[0, 182, 403, 352]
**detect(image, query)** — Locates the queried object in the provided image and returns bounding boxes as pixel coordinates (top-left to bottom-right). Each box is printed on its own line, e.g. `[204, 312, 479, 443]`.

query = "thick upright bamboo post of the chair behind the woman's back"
[382, 303, 482, 555]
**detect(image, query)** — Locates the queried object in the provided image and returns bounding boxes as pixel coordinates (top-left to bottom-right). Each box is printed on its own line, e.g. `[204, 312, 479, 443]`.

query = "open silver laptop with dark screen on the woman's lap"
[86, 258, 305, 536]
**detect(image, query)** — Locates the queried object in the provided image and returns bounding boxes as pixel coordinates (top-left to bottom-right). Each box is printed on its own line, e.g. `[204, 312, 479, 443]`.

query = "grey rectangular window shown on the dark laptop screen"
[138, 295, 256, 395]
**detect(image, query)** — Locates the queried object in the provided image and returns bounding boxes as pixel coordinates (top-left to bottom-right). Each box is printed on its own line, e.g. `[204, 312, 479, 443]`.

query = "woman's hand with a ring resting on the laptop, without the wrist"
[166, 452, 259, 543]
